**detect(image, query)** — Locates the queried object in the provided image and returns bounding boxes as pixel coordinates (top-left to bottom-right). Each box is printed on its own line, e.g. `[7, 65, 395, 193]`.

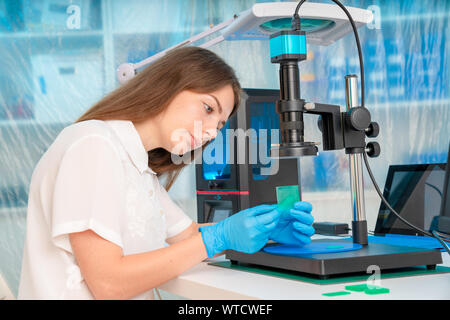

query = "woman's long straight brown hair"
[75, 47, 241, 190]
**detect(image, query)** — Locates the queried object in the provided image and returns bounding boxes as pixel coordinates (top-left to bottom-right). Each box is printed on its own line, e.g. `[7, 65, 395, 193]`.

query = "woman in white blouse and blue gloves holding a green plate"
[19, 47, 314, 299]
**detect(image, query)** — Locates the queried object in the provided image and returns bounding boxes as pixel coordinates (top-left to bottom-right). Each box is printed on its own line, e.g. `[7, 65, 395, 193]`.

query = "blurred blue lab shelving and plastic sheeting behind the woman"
[0, 0, 450, 296]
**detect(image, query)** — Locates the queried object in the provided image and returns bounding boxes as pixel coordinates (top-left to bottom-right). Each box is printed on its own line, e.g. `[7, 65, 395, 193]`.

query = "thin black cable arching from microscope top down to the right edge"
[292, 0, 450, 255]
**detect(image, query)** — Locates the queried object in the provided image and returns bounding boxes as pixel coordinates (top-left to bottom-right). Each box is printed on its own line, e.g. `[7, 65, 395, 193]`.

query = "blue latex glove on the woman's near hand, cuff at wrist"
[199, 204, 281, 257]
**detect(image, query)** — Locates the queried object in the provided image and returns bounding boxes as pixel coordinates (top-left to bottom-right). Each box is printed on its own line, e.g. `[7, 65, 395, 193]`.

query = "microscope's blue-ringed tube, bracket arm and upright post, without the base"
[270, 30, 380, 245]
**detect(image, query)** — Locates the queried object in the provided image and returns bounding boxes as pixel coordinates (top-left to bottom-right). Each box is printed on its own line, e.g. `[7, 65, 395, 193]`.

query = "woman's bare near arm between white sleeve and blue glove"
[69, 230, 207, 299]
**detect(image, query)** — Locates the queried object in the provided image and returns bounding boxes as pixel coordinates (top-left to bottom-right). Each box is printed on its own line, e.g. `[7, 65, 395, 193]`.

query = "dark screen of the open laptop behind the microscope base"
[375, 163, 446, 235]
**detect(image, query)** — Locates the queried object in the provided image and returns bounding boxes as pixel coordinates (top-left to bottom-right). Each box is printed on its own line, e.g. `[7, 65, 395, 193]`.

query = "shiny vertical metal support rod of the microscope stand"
[345, 75, 368, 244]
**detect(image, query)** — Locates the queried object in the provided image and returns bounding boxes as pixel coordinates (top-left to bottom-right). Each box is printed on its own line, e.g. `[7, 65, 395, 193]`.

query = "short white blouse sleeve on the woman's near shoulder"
[50, 135, 126, 253]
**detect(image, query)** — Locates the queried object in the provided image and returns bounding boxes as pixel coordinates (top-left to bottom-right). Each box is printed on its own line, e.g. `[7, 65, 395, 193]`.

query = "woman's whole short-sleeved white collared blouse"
[18, 120, 192, 299]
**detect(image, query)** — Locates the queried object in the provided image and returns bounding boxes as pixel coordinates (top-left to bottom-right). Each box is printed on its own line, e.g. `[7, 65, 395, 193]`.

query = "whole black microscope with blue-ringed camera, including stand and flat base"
[226, 3, 442, 279]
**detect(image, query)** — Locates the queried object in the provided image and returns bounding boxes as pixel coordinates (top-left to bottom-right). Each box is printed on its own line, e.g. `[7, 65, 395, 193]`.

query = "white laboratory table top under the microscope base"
[160, 235, 450, 300]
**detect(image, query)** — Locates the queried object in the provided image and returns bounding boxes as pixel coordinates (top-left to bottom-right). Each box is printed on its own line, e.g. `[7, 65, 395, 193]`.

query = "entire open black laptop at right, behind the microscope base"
[371, 146, 450, 249]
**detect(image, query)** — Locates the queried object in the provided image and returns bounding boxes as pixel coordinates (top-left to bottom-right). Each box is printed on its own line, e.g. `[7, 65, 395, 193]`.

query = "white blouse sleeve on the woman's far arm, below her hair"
[158, 184, 192, 238]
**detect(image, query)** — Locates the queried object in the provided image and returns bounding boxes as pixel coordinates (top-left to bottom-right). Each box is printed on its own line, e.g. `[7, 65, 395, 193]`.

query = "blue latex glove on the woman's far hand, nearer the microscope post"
[269, 201, 315, 246]
